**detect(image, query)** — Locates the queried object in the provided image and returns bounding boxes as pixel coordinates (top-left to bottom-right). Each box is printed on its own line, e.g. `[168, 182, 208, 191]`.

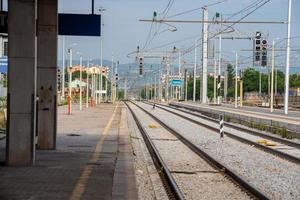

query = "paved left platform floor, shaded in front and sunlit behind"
[0, 104, 137, 200]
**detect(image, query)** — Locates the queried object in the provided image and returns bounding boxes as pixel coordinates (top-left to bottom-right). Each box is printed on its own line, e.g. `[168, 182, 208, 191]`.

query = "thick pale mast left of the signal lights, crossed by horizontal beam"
[202, 7, 208, 104]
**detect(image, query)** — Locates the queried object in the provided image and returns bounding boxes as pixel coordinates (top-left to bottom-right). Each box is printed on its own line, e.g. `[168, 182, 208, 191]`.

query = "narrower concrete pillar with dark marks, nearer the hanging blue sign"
[37, 0, 58, 149]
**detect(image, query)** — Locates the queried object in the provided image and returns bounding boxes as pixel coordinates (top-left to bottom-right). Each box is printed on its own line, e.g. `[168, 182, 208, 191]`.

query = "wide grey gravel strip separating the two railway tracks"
[138, 103, 300, 199]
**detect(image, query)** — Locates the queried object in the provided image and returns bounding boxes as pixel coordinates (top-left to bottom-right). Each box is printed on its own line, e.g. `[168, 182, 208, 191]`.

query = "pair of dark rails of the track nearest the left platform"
[126, 102, 269, 199]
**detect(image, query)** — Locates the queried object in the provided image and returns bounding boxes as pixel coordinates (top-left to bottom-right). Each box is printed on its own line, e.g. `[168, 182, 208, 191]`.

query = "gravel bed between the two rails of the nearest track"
[132, 102, 250, 199]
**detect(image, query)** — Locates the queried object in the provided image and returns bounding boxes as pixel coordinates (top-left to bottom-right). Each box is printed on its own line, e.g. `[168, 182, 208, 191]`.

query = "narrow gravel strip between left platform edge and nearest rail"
[126, 105, 167, 200]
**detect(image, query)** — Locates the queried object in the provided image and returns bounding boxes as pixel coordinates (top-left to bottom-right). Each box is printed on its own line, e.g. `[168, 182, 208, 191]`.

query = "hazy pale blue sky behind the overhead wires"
[58, 0, 300, 72]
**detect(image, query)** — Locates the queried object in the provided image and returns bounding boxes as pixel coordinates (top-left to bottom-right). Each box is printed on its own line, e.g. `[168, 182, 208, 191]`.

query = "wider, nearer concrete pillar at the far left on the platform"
[6, 0, 36, 166]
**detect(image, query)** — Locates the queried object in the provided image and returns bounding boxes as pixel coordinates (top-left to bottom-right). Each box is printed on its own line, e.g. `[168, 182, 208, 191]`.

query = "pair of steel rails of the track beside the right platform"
[144, 102, 300, 164]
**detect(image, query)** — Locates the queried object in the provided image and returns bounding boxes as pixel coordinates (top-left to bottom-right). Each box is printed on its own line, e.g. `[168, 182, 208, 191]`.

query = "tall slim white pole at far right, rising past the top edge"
[284, 0, 292, 115]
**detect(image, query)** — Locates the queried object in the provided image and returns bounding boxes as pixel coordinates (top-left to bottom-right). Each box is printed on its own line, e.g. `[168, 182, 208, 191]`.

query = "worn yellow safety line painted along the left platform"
[70, 103, 119, 200]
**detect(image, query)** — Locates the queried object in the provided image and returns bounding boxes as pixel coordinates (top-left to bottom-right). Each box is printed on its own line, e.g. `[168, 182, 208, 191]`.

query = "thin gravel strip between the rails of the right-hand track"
[158, 104, 300, 158]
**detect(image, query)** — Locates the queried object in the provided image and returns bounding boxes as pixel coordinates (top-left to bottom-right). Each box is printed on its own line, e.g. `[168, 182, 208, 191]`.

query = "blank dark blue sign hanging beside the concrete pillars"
[58, 14, 101, 36]
